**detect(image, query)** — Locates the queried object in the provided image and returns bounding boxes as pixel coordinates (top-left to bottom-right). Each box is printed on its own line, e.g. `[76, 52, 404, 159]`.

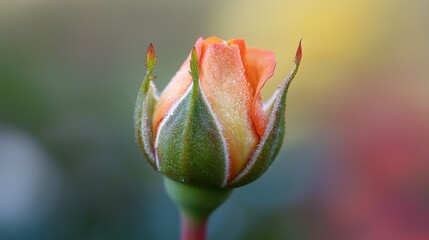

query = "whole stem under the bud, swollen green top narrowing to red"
[164, 178, 232, 240]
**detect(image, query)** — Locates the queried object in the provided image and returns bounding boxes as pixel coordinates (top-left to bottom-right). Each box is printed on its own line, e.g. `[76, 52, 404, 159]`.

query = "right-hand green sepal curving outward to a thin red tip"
[228, 52, 301, 187]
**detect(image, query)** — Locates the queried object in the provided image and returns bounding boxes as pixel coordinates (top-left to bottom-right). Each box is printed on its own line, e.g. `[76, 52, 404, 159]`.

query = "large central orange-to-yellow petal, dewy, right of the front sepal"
[200, 43, 259, 180]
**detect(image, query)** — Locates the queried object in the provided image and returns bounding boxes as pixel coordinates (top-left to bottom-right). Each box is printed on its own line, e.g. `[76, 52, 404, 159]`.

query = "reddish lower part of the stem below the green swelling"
[180, 212, 207, 240]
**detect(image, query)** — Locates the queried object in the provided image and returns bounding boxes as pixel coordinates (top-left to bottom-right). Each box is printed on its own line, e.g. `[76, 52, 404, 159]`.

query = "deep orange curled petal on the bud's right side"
[246, 48, 276, 136]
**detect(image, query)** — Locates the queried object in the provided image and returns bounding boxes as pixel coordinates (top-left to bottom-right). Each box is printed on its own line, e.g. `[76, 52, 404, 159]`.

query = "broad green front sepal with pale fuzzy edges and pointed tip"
[155, 49, 228, 188]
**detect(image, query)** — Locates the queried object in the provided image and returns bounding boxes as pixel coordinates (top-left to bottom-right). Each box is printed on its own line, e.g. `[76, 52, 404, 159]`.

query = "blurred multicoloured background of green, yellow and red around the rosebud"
[0, 0, 429, 240]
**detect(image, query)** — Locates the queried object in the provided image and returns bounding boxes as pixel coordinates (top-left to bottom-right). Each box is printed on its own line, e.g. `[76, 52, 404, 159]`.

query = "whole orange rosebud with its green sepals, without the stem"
[135, 37, 301, 188]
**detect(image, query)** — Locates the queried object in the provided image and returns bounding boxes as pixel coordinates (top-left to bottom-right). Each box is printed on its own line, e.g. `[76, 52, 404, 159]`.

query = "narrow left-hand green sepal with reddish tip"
[134, 44, 157, 169]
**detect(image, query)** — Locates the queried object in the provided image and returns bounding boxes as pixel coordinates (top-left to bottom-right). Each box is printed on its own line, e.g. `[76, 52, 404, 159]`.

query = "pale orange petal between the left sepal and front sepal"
[152, 38, 204, 135]
